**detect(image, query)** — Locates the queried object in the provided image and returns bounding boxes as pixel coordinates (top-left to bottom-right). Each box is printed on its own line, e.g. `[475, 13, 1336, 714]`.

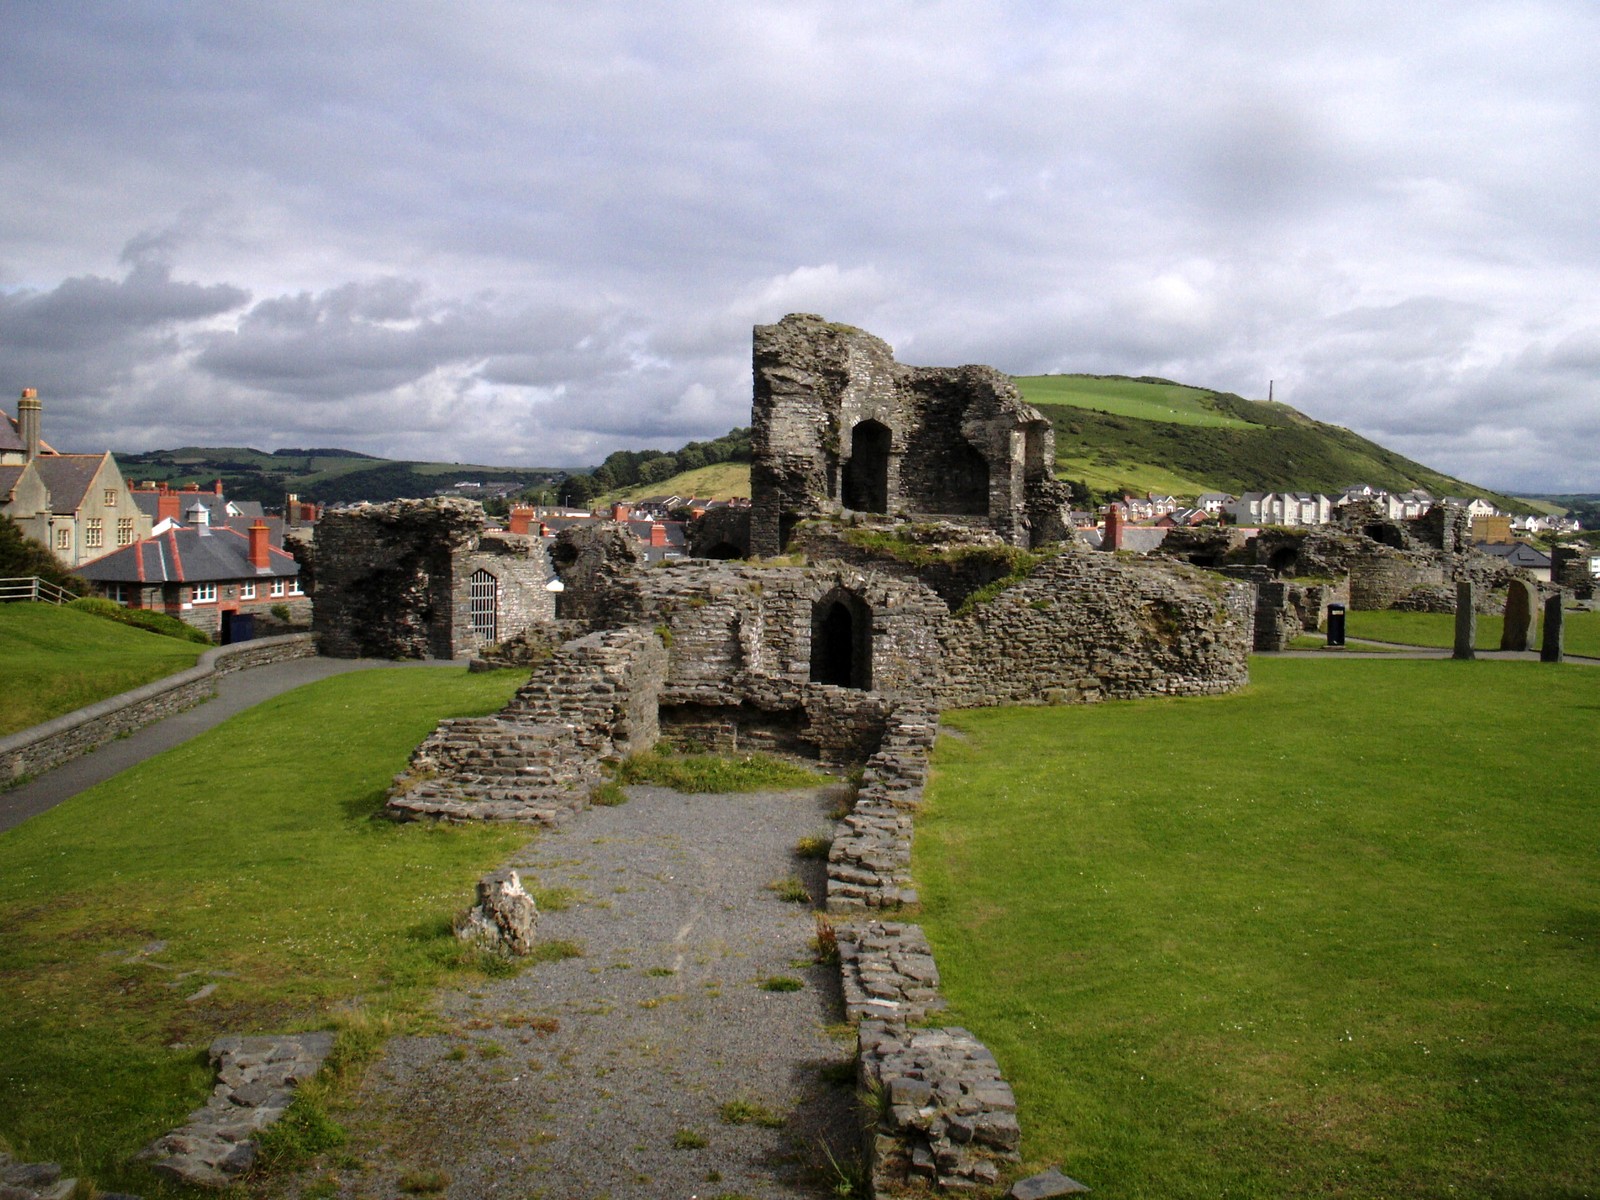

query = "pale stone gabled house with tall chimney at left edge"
[0, 387, 150, 568]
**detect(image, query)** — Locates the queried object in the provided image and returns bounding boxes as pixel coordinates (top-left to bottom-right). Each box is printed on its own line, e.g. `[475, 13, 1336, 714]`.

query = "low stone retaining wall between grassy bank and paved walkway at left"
[0, 634, 317, 787]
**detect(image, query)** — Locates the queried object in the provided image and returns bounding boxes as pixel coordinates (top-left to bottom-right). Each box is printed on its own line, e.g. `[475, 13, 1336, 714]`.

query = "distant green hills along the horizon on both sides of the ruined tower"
[117, 374, 1536, 512]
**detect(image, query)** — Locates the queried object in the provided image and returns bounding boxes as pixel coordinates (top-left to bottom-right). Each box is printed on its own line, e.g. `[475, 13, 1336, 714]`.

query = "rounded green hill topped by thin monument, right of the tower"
[1016, 374, 1528, 510]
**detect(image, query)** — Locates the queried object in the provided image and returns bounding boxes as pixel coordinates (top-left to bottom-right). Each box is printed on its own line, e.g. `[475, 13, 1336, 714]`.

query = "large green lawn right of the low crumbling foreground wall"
[914, 658, 1600, 1200]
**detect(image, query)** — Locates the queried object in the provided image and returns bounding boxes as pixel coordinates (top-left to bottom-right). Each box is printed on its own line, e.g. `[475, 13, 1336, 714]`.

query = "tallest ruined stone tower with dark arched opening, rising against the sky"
[750, 314, 1067, 555]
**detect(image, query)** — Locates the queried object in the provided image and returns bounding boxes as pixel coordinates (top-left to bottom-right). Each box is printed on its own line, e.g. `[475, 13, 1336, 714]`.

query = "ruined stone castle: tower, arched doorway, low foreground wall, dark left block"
[371, 315, 1254, 1190]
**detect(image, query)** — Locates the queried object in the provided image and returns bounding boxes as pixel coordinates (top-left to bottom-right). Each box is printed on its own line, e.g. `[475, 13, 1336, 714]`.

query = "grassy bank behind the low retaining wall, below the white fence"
[0, 603, 206, 736]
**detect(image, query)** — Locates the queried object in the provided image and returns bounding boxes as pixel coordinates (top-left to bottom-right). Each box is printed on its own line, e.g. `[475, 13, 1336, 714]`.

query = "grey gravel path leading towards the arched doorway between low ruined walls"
[350, 787, 856, 1200]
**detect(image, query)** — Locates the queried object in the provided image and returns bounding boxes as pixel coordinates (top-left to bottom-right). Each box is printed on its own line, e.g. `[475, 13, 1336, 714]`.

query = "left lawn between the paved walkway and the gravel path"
[0, 668, 528, 1197]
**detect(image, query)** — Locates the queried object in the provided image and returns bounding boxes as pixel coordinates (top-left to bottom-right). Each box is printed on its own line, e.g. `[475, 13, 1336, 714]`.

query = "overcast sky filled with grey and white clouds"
[0, 0, 1600, 491]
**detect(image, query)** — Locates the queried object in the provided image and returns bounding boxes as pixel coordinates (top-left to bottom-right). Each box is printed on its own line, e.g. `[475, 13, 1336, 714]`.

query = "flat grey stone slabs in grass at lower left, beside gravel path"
[139, 1034, 333, 1187]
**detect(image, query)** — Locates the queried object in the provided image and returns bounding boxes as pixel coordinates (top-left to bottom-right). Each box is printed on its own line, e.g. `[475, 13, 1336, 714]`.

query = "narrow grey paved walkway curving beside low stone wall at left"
[0, 658, 464, 834]
